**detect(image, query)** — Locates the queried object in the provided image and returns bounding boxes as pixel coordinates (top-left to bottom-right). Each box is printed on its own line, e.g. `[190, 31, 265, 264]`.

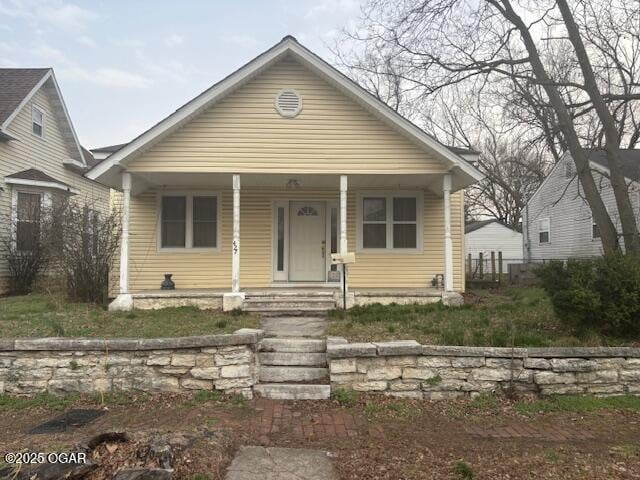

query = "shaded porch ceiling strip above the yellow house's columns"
[127, 172, 462, 195]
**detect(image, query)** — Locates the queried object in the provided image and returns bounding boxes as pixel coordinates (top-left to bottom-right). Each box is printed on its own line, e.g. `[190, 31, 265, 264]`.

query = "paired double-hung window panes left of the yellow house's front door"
[159, 194, 219, 249]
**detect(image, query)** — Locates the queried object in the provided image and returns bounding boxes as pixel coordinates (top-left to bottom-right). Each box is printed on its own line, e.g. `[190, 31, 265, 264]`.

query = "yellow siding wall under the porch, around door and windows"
[120, 189, 464, 293]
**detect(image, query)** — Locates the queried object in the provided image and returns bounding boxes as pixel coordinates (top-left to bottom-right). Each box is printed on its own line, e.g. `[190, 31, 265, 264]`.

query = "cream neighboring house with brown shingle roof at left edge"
[0, 68, 109, 294]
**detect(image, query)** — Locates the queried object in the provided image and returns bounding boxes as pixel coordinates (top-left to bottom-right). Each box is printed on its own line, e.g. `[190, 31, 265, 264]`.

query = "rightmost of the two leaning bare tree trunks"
[556, 0, 640, 253]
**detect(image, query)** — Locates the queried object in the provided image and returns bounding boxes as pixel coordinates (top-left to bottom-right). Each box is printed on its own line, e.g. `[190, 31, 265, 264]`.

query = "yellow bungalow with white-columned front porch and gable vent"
[88, 36, 481, 310]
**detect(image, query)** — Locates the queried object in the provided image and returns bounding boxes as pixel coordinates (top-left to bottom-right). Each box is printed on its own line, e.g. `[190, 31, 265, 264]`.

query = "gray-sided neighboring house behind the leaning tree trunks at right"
[523, 150, 640, 261]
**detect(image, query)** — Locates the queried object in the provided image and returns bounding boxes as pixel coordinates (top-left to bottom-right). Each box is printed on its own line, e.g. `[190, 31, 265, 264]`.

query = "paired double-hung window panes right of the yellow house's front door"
[359, 194, 422, 252]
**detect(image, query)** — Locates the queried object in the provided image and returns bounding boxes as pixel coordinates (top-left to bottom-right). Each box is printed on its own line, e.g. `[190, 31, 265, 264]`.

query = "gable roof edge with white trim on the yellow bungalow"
[86, 35, 483, 184]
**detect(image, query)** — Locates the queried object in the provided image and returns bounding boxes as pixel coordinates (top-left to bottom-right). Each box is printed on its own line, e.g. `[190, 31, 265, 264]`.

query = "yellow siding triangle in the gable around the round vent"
[127, 59, 445, 174]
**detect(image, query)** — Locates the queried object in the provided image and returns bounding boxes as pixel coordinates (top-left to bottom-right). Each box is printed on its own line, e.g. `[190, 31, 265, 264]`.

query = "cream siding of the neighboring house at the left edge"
[0, 84, 109, 293]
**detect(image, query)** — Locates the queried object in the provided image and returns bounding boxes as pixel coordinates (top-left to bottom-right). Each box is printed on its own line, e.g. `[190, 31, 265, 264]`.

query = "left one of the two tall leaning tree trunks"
[496, 0, 619, 253]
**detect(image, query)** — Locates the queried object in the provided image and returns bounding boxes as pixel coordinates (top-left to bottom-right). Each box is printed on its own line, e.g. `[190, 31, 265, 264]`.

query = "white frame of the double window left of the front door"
[156, 190, 222, 253]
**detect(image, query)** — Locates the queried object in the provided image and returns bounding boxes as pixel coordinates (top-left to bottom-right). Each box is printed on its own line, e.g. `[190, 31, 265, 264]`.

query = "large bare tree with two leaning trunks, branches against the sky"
[336, 0, 640, 252]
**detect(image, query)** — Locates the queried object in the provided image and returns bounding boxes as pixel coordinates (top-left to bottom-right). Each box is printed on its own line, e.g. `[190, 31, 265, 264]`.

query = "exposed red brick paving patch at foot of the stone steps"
[252, 399, 358, 438]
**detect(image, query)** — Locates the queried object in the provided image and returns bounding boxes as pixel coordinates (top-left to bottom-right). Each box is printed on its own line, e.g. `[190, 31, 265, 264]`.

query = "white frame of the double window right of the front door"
[356, 190, 424, 255]
